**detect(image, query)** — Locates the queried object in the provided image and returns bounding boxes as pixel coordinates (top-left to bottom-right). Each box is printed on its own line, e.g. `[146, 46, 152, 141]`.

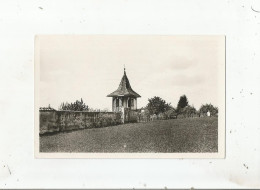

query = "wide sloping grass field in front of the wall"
[40, 117, 218, 153]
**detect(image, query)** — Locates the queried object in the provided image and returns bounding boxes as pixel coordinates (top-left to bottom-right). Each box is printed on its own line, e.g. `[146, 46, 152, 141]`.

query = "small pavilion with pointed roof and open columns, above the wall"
[107, 69, 141, 112]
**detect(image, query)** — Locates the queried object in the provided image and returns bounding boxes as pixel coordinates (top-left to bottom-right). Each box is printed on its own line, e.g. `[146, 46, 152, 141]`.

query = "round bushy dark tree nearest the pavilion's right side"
[146, 96, 172, 115]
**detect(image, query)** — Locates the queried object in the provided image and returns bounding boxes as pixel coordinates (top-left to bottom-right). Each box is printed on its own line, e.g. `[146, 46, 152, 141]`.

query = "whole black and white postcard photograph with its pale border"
[35, 35, 225, 158]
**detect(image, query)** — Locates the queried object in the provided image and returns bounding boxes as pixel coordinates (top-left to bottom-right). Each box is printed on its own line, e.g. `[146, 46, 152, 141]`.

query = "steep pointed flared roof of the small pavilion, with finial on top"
[107, 69, 141, 98]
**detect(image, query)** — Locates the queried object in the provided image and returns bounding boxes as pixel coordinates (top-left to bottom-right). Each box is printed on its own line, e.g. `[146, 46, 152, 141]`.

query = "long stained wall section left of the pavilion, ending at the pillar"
[39, 110, 122, 134]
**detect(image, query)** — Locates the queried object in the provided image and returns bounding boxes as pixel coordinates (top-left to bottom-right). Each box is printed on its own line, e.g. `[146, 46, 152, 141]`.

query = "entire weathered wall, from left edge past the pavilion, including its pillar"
[39, 108, 182, 134]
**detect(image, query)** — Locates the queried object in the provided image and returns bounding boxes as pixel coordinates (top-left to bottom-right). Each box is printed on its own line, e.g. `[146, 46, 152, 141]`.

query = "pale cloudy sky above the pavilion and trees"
[36, 35, 225, 110]
